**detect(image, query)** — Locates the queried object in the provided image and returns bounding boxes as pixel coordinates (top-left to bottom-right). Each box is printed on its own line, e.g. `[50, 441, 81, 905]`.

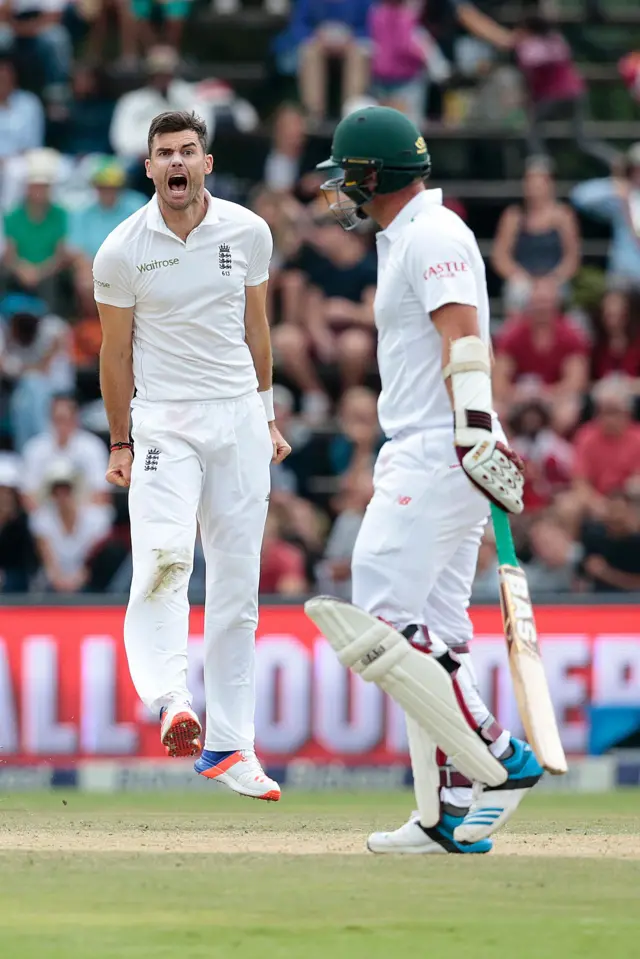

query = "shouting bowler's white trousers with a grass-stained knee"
[124, 390, 272, 750]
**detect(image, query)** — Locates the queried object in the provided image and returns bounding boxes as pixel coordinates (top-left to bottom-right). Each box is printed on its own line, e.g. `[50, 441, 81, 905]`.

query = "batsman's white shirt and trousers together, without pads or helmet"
[352, 190, 498, 646]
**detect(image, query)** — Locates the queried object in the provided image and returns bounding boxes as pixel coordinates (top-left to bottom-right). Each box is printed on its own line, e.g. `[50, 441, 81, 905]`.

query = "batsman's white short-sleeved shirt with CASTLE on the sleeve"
[374, 190, 490, 438]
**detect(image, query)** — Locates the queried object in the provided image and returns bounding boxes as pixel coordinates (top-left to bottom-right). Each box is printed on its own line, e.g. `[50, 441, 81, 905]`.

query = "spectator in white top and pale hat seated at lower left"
[30, 459, 111, 593]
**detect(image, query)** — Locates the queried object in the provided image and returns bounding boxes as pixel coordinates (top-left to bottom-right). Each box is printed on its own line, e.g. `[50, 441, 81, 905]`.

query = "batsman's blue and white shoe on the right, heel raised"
[454, 738, 544, 846]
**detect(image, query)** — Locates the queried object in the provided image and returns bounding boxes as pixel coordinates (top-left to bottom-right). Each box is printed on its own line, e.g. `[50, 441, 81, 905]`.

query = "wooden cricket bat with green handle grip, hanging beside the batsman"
[491, 505, 567, 776]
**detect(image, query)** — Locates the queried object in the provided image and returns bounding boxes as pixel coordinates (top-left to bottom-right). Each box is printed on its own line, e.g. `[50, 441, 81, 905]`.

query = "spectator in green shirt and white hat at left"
[3, 149, 68, 306]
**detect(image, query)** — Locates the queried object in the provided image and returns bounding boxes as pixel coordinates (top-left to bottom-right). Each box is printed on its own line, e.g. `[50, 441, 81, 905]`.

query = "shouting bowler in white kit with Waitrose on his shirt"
[94, 113, 290, 800]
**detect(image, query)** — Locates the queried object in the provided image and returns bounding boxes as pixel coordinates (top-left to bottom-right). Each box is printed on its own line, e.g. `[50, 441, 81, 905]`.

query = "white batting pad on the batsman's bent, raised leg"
[304, 596, 507, 786]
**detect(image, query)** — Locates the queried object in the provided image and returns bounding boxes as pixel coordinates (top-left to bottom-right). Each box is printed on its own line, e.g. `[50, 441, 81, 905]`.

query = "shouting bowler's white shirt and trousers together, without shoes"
[94, 194, 272, 750]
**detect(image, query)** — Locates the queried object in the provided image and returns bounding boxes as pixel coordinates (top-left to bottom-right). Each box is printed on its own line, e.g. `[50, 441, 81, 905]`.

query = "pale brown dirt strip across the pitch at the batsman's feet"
[0, 826, 640, 860]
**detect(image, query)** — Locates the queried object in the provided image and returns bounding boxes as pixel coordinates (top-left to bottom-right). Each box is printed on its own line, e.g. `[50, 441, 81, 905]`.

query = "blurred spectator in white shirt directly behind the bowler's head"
[110, 46, 213, 164]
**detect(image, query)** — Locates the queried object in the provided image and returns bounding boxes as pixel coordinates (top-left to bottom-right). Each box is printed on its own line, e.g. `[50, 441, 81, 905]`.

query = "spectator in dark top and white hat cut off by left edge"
[0, 454, 37, 593]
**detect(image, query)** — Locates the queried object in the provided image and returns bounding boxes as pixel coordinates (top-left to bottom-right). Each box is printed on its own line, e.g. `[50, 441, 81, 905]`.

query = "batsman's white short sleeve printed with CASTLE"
[405, 230, 479, 313]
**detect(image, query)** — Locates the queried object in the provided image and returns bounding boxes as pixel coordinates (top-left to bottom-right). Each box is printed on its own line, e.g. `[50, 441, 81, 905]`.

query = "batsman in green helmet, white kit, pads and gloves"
[306, 107, 542, 853]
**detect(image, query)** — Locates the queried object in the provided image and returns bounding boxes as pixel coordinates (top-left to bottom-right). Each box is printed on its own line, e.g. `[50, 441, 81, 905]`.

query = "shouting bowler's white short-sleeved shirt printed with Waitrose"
[93, 193, 273, 405]
